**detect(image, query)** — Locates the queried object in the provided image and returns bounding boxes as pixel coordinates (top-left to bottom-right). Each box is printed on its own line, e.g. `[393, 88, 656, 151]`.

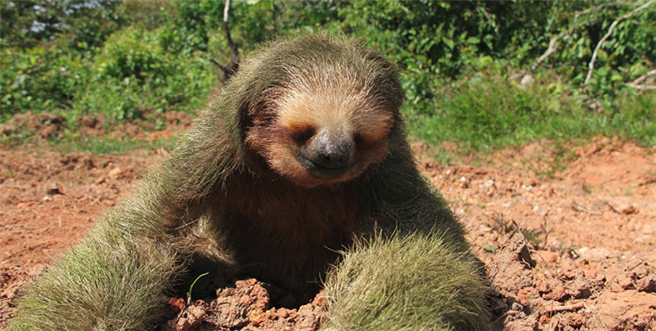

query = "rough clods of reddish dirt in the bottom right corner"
[487, 233, 656, 331]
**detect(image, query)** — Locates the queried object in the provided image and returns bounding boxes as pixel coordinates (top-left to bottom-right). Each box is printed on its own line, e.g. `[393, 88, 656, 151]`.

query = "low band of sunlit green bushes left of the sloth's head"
[0, 27, 217, 123]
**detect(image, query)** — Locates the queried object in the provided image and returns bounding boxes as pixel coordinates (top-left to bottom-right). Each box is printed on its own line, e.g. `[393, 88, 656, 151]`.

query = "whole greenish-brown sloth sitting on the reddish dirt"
[9, 34, 488, 330]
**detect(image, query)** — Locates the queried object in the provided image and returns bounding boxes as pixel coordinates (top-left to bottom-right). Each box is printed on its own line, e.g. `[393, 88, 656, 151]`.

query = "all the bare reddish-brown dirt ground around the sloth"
[0, 115, 656, 331]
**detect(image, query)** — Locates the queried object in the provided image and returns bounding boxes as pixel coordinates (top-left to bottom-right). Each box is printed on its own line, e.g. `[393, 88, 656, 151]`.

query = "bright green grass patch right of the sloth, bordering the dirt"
[405, 69, 656, 156]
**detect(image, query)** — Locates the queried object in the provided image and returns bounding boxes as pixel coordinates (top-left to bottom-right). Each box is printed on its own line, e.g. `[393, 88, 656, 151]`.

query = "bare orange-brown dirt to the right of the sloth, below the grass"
[415, 137, 656, 330]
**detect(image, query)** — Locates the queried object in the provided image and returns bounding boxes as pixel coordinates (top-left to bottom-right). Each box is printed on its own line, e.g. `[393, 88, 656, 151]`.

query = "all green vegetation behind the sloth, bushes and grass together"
[0, 0, 656, 151]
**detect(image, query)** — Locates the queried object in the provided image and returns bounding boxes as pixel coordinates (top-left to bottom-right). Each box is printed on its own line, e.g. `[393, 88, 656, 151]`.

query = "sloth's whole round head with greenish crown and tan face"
[245, 36, 403, 187]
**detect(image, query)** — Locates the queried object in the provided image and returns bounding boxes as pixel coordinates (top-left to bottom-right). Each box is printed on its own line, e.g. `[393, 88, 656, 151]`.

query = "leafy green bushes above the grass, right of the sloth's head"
[304, 0, 656, 111]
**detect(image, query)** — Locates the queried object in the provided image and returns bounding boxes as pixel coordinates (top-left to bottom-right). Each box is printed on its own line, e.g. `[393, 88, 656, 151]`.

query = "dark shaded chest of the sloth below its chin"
[220, 182, 362, 289]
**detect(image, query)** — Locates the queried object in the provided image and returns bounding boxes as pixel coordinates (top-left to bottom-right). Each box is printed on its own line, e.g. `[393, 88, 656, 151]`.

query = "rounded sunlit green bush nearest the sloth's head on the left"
[75, 27, 216, 120]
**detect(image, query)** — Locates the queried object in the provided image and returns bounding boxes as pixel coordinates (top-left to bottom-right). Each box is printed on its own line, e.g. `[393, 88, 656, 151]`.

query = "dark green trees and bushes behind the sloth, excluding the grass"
[0, 0, 656, 147]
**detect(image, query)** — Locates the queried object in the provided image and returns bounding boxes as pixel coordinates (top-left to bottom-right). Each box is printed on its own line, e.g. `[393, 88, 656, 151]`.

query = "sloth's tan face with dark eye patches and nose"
[248, 87, 394, 187]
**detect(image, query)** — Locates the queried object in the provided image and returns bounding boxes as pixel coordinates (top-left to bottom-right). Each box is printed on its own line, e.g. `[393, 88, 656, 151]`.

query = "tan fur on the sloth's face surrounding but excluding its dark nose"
[249, 70, 394, 187]
